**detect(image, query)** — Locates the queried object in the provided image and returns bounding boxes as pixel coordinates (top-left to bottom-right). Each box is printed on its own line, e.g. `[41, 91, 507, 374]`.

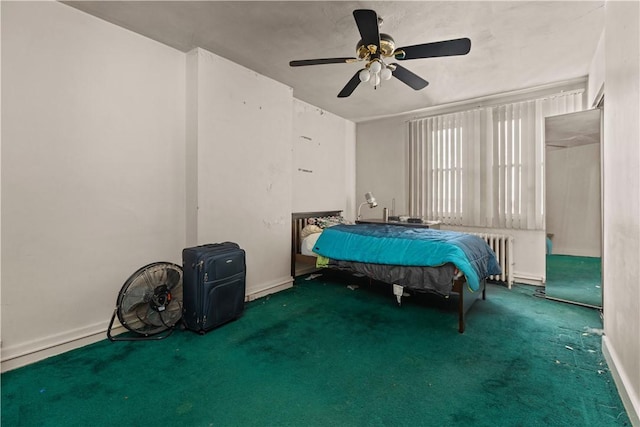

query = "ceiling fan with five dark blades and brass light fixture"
[289, 9, 471, 98]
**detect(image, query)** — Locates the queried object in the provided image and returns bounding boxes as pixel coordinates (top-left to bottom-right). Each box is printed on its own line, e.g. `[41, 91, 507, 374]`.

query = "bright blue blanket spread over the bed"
[313, 224, 501, 291]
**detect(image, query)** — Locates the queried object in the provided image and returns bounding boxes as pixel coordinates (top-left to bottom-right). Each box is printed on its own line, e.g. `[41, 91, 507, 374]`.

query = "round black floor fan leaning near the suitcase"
[107, 262, 182, 341]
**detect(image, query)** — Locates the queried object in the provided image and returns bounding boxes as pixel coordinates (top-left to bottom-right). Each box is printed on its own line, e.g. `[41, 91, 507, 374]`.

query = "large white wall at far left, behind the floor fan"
[1, 2, 185, 370]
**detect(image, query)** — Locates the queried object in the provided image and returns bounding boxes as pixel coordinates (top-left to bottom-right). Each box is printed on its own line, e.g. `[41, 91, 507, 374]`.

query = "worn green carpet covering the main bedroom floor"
[1, 274, 630, 427]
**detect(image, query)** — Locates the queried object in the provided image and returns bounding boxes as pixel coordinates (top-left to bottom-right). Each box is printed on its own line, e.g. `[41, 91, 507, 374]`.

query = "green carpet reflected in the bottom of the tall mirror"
[545, 255, 602, 307]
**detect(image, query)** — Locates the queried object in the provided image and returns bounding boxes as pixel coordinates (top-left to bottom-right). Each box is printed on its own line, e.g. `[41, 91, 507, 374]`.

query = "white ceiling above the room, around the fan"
[64, 0, 604, 121]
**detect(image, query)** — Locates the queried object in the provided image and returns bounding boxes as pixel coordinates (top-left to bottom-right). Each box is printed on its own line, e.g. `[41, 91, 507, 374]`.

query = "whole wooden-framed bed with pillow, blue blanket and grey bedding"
[292, 211, 500, 333]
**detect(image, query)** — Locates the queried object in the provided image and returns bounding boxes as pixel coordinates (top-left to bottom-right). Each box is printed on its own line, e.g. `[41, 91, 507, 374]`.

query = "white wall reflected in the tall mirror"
[545, 144, 602, 257]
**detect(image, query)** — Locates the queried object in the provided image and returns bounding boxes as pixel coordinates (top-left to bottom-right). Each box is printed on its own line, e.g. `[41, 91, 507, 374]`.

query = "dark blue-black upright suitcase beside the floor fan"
[182, 242, 246, 334]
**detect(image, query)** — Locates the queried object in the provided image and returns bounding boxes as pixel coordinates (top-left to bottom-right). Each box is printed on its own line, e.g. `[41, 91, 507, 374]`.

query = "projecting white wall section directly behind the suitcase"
[187, 49, 293, 297]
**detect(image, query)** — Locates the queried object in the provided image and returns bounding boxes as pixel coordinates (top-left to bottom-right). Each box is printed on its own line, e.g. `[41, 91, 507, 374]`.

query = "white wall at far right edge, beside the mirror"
[602, 1, 640, 425]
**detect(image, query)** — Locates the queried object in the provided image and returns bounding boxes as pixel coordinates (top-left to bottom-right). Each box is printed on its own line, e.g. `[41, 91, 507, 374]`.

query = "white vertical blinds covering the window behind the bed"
[409, 91, 583, 230]
